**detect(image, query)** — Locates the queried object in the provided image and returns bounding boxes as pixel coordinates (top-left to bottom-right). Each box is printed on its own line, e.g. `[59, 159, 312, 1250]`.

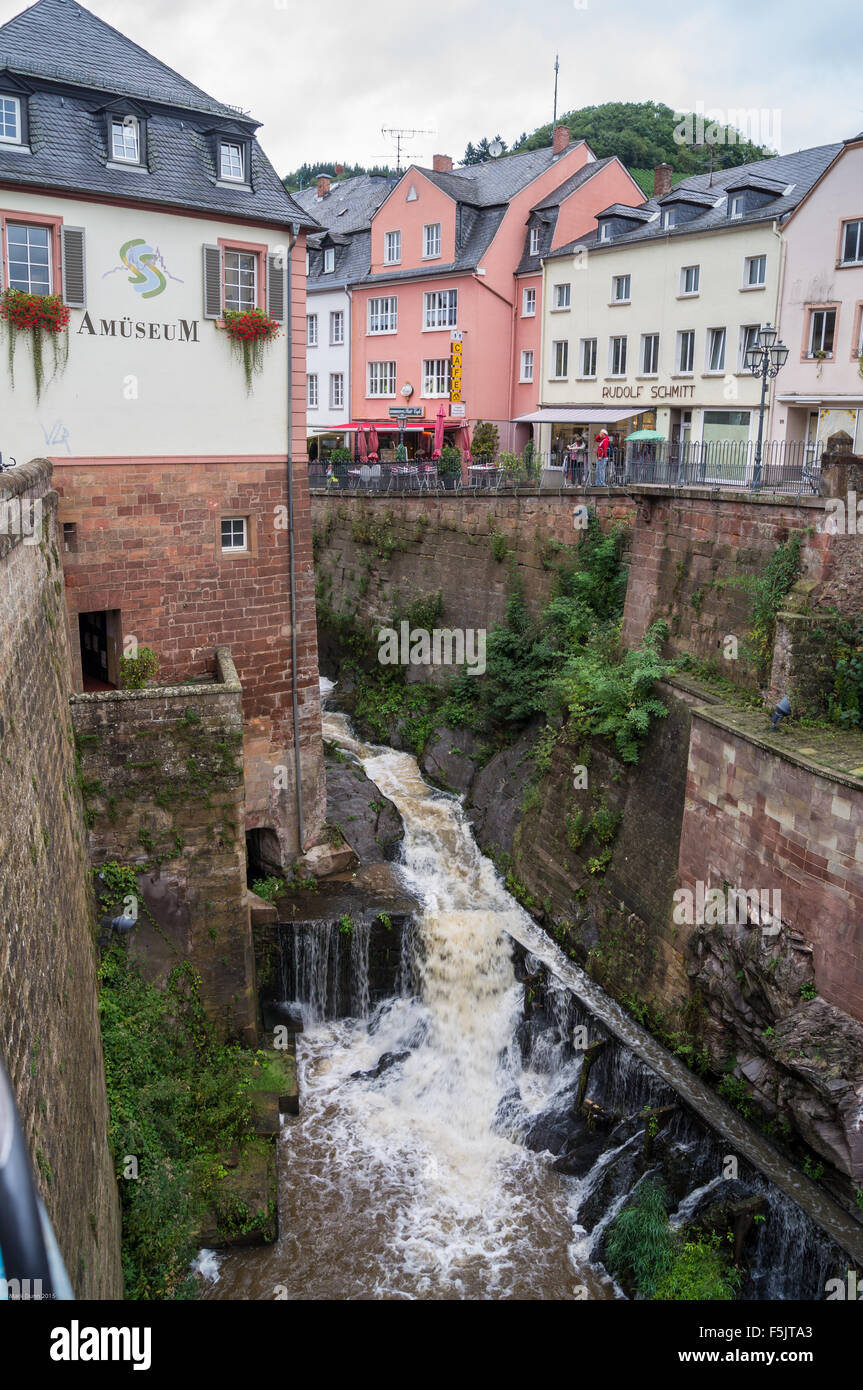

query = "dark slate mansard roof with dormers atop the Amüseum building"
[0, 0, 317, 227]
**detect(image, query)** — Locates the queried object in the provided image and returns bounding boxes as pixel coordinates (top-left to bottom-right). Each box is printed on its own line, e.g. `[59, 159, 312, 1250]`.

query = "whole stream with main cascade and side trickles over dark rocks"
[204, 692, 863, 1300]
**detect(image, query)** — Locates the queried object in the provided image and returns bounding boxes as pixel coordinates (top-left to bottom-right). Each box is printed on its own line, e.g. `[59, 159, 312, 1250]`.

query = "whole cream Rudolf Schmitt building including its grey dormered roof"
[532, 146, 839, 475]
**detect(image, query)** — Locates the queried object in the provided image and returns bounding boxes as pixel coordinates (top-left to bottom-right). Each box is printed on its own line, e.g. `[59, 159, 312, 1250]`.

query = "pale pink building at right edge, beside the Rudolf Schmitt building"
[771, 133, 863, 453]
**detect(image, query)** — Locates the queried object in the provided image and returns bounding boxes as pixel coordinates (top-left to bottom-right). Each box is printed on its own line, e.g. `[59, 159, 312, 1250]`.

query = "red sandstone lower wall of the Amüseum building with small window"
[56, 459, 324, 855]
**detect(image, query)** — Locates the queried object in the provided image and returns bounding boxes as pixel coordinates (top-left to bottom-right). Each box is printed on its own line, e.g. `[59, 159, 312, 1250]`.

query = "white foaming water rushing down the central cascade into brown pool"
[208, 713, 614, 1298]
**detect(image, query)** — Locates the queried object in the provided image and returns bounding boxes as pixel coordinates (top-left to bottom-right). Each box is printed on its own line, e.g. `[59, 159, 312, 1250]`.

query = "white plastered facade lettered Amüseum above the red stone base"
[0, 189, 296, 461]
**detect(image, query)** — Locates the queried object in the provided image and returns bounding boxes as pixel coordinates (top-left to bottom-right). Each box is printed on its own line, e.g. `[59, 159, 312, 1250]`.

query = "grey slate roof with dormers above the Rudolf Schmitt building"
[545, 145, 842, 260]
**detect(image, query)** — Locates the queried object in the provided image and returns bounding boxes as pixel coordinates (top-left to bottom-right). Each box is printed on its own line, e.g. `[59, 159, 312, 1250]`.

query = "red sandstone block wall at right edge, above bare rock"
[678, 710, 863, 1019]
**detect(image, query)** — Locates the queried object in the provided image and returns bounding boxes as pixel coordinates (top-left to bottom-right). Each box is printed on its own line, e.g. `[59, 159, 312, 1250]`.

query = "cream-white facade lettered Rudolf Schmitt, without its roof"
[538, 222, 781, 450]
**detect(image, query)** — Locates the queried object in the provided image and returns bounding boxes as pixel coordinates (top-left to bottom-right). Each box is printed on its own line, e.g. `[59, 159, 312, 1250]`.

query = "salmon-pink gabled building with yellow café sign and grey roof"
[352, 126, 643, 450]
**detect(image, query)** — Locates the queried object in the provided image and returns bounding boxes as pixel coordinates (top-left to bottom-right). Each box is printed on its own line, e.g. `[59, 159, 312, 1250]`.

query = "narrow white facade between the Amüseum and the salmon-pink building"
[306, 282, 350, 435]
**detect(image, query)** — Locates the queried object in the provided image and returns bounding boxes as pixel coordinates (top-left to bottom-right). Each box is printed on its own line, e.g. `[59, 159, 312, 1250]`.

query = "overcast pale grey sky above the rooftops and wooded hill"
[0, 0, 863, 174]
